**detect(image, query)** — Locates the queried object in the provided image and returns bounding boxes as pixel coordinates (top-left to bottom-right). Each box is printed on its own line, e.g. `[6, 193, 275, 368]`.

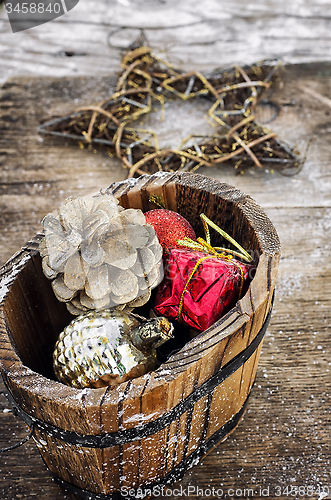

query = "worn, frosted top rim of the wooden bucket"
[0, 172, 280, 406]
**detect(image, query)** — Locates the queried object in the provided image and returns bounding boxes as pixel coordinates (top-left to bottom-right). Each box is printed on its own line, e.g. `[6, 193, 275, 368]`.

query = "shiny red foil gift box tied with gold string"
[154, 248, 253, 331]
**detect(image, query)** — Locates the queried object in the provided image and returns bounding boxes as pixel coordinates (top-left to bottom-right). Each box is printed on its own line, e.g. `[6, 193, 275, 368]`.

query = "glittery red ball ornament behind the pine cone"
[145, 208, 196, 251]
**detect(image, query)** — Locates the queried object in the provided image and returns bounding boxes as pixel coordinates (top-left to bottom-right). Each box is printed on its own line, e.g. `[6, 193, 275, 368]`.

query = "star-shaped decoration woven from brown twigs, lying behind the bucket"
[39, 46, 303, 177]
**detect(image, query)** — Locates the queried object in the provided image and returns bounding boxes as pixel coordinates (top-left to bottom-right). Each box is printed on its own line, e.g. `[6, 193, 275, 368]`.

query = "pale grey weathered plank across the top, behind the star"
[0, 0, 331, 81]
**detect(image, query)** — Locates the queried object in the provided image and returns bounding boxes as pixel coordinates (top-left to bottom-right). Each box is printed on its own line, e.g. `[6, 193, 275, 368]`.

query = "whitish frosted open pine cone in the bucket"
[39, 193, 163, 315]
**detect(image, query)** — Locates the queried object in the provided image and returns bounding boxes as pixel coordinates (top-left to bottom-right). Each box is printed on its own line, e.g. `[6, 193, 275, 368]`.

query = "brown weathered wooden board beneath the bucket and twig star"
[0, 54, 331, 500]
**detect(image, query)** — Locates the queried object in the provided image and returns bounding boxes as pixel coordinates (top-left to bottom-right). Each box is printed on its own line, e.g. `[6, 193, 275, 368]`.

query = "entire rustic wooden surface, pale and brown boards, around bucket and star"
[0, 0, 331, 500]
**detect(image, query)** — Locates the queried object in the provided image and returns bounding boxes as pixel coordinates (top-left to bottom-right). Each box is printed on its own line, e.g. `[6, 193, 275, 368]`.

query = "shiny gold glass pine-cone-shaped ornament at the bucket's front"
[53, 310, 173, 388]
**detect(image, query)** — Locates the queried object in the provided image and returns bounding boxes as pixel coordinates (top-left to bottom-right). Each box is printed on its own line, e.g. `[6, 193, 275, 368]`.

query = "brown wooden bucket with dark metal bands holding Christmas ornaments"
[0, 173, 280, 500]
